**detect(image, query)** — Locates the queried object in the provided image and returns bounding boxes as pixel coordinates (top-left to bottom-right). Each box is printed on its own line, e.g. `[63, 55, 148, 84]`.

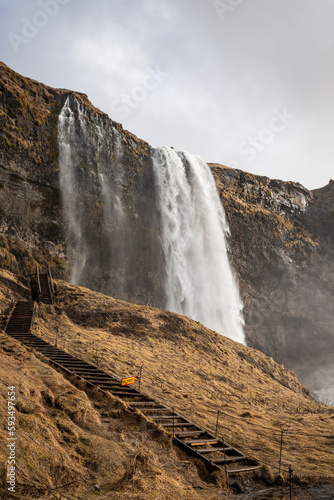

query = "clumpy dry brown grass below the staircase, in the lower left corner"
[0, 334, 226, 500]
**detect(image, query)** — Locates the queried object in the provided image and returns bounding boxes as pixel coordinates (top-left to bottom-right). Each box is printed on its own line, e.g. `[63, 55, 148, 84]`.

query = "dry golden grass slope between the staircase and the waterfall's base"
[35, 282, 334, 482]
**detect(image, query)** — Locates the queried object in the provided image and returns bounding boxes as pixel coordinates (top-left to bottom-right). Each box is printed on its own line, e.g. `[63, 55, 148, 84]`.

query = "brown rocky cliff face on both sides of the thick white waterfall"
[0, 64, 334, 396]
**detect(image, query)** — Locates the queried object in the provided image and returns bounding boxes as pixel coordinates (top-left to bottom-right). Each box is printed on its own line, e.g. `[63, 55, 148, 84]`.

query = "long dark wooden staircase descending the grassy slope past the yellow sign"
[6, 324, 260, 474]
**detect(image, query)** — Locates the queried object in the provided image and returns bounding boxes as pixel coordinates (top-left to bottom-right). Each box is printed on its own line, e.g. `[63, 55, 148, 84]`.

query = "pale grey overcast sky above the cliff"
[0, 0, 334, 189]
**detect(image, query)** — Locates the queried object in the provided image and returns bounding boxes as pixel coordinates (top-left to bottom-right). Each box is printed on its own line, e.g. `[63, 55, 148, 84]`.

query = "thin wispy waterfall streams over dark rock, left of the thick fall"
[58, 96, 127, 293]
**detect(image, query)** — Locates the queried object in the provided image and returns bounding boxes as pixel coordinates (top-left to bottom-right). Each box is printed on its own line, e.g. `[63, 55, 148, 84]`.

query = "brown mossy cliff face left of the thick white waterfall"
[0, 63, 162, 304]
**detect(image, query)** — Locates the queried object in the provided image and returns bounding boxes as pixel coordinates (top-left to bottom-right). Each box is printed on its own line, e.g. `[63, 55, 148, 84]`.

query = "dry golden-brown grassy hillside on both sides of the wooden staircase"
[0, 271, 334, 499]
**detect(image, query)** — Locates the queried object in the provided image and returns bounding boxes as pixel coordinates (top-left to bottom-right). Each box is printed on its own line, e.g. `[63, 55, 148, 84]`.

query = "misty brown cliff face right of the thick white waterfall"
[211, 164, 334, 389]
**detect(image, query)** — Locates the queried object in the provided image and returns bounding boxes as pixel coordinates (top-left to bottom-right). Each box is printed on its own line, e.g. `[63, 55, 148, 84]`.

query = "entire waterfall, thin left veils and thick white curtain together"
[58, 95, 244, 342]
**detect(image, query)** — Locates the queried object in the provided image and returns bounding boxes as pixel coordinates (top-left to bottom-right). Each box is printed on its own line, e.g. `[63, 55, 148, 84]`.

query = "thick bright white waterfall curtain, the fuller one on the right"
[153, 147, 245, 343]
